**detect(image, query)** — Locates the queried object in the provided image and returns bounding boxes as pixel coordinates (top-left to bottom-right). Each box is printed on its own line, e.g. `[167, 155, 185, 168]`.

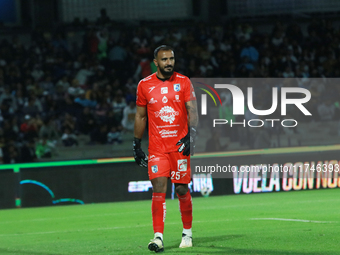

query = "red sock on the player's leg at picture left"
[151, 193, 166, 234]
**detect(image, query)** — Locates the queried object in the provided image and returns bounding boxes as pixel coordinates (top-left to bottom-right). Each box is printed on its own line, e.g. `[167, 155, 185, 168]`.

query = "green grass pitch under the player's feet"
[0, 189, 340, 255]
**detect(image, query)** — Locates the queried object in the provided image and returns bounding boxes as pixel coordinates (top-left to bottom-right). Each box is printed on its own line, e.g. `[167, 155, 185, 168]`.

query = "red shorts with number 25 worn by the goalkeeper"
[148, 150, 191, 184]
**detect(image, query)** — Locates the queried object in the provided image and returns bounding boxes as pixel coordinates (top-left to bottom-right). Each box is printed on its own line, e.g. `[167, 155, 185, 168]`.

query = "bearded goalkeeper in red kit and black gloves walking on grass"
[133, 45, 198, 252]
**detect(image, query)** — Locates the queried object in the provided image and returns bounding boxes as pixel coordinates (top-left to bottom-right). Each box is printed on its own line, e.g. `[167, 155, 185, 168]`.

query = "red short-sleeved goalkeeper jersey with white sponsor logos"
[136, 72, 196, 153]
